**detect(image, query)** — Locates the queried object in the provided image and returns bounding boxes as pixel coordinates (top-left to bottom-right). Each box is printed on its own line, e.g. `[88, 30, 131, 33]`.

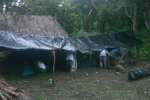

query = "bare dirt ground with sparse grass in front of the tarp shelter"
[4, 68, 150, 100]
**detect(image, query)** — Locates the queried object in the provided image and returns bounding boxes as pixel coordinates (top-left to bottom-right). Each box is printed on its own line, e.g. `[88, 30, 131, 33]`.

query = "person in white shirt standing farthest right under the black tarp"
[99, 49, 110, 68]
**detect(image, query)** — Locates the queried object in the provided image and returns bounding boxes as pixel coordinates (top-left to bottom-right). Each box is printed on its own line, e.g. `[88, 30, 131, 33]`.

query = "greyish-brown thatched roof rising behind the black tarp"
[0, 15, 67, 37]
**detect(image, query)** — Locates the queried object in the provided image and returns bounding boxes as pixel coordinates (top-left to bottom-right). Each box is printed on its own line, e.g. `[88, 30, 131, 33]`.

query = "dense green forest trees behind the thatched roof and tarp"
[0, 0, 150, 61]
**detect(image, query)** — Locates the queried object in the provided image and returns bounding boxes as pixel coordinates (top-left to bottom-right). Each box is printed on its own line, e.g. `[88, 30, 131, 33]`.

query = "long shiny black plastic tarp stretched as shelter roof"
[0, 31, 138, 75]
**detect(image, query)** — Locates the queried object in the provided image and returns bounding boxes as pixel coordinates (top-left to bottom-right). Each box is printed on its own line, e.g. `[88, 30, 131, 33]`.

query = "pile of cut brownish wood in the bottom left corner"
[0, 80, 31, 100]
